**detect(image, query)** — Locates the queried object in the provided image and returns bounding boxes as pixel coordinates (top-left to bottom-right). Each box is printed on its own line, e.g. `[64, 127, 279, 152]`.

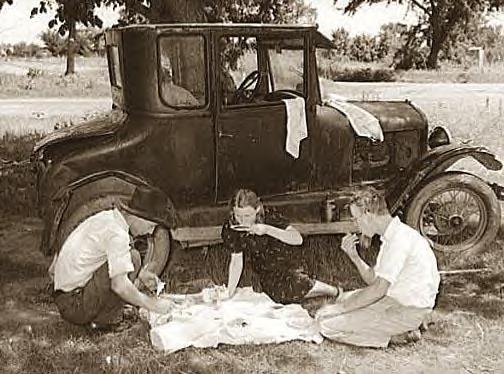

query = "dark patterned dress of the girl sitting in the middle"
[222, 210, 315, 303]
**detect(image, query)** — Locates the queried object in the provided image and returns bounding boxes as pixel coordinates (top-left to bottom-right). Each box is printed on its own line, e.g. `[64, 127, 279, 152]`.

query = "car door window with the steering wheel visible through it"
[219, 36, 305, 106]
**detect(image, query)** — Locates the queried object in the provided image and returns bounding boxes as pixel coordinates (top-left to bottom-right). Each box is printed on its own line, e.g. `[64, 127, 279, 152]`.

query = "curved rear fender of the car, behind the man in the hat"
[40, 170, 177, 255]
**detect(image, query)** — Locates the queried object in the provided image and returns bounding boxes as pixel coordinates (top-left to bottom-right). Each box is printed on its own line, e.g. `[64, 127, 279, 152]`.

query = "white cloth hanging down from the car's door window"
[282, 97, 308, 158]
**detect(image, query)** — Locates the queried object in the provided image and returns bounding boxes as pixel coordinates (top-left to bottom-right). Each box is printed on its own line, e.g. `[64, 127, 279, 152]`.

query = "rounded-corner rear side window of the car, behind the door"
[158, 35, 207, 108]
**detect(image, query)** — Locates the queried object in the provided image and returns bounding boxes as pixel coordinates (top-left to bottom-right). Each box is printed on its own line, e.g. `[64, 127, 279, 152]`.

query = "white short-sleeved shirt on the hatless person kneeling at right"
[374, 217, 440, 308]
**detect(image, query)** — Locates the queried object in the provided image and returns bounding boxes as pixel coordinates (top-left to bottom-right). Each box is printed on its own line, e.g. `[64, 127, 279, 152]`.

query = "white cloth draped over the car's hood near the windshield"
[324, 95, 383, 142]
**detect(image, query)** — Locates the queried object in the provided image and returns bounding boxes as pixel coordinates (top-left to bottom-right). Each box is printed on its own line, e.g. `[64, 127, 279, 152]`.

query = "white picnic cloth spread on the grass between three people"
[144, 287, 323, 352]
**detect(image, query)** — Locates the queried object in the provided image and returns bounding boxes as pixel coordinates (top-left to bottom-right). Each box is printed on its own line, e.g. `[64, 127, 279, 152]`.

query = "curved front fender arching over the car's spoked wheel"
[387, 144, 502, 213]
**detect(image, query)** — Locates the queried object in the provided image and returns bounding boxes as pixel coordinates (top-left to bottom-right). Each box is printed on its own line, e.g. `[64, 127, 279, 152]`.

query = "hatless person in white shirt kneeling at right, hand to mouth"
[316, 187, 439, 348]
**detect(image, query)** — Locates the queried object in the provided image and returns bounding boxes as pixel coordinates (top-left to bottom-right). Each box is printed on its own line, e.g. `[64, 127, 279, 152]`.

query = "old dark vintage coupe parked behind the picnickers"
[32, 24, 503, 262]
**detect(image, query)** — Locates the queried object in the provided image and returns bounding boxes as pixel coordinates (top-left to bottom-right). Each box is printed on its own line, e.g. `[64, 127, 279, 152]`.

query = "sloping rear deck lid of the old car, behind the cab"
[33, 111, 126, 153]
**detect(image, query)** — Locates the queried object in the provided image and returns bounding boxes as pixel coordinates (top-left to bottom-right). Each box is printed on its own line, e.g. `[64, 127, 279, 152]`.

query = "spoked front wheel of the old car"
[406, 172, 501, 257]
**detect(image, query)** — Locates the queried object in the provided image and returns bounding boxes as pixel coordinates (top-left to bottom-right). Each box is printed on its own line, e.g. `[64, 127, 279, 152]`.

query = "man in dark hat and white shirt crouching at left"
[49, 187, 172, 328]
